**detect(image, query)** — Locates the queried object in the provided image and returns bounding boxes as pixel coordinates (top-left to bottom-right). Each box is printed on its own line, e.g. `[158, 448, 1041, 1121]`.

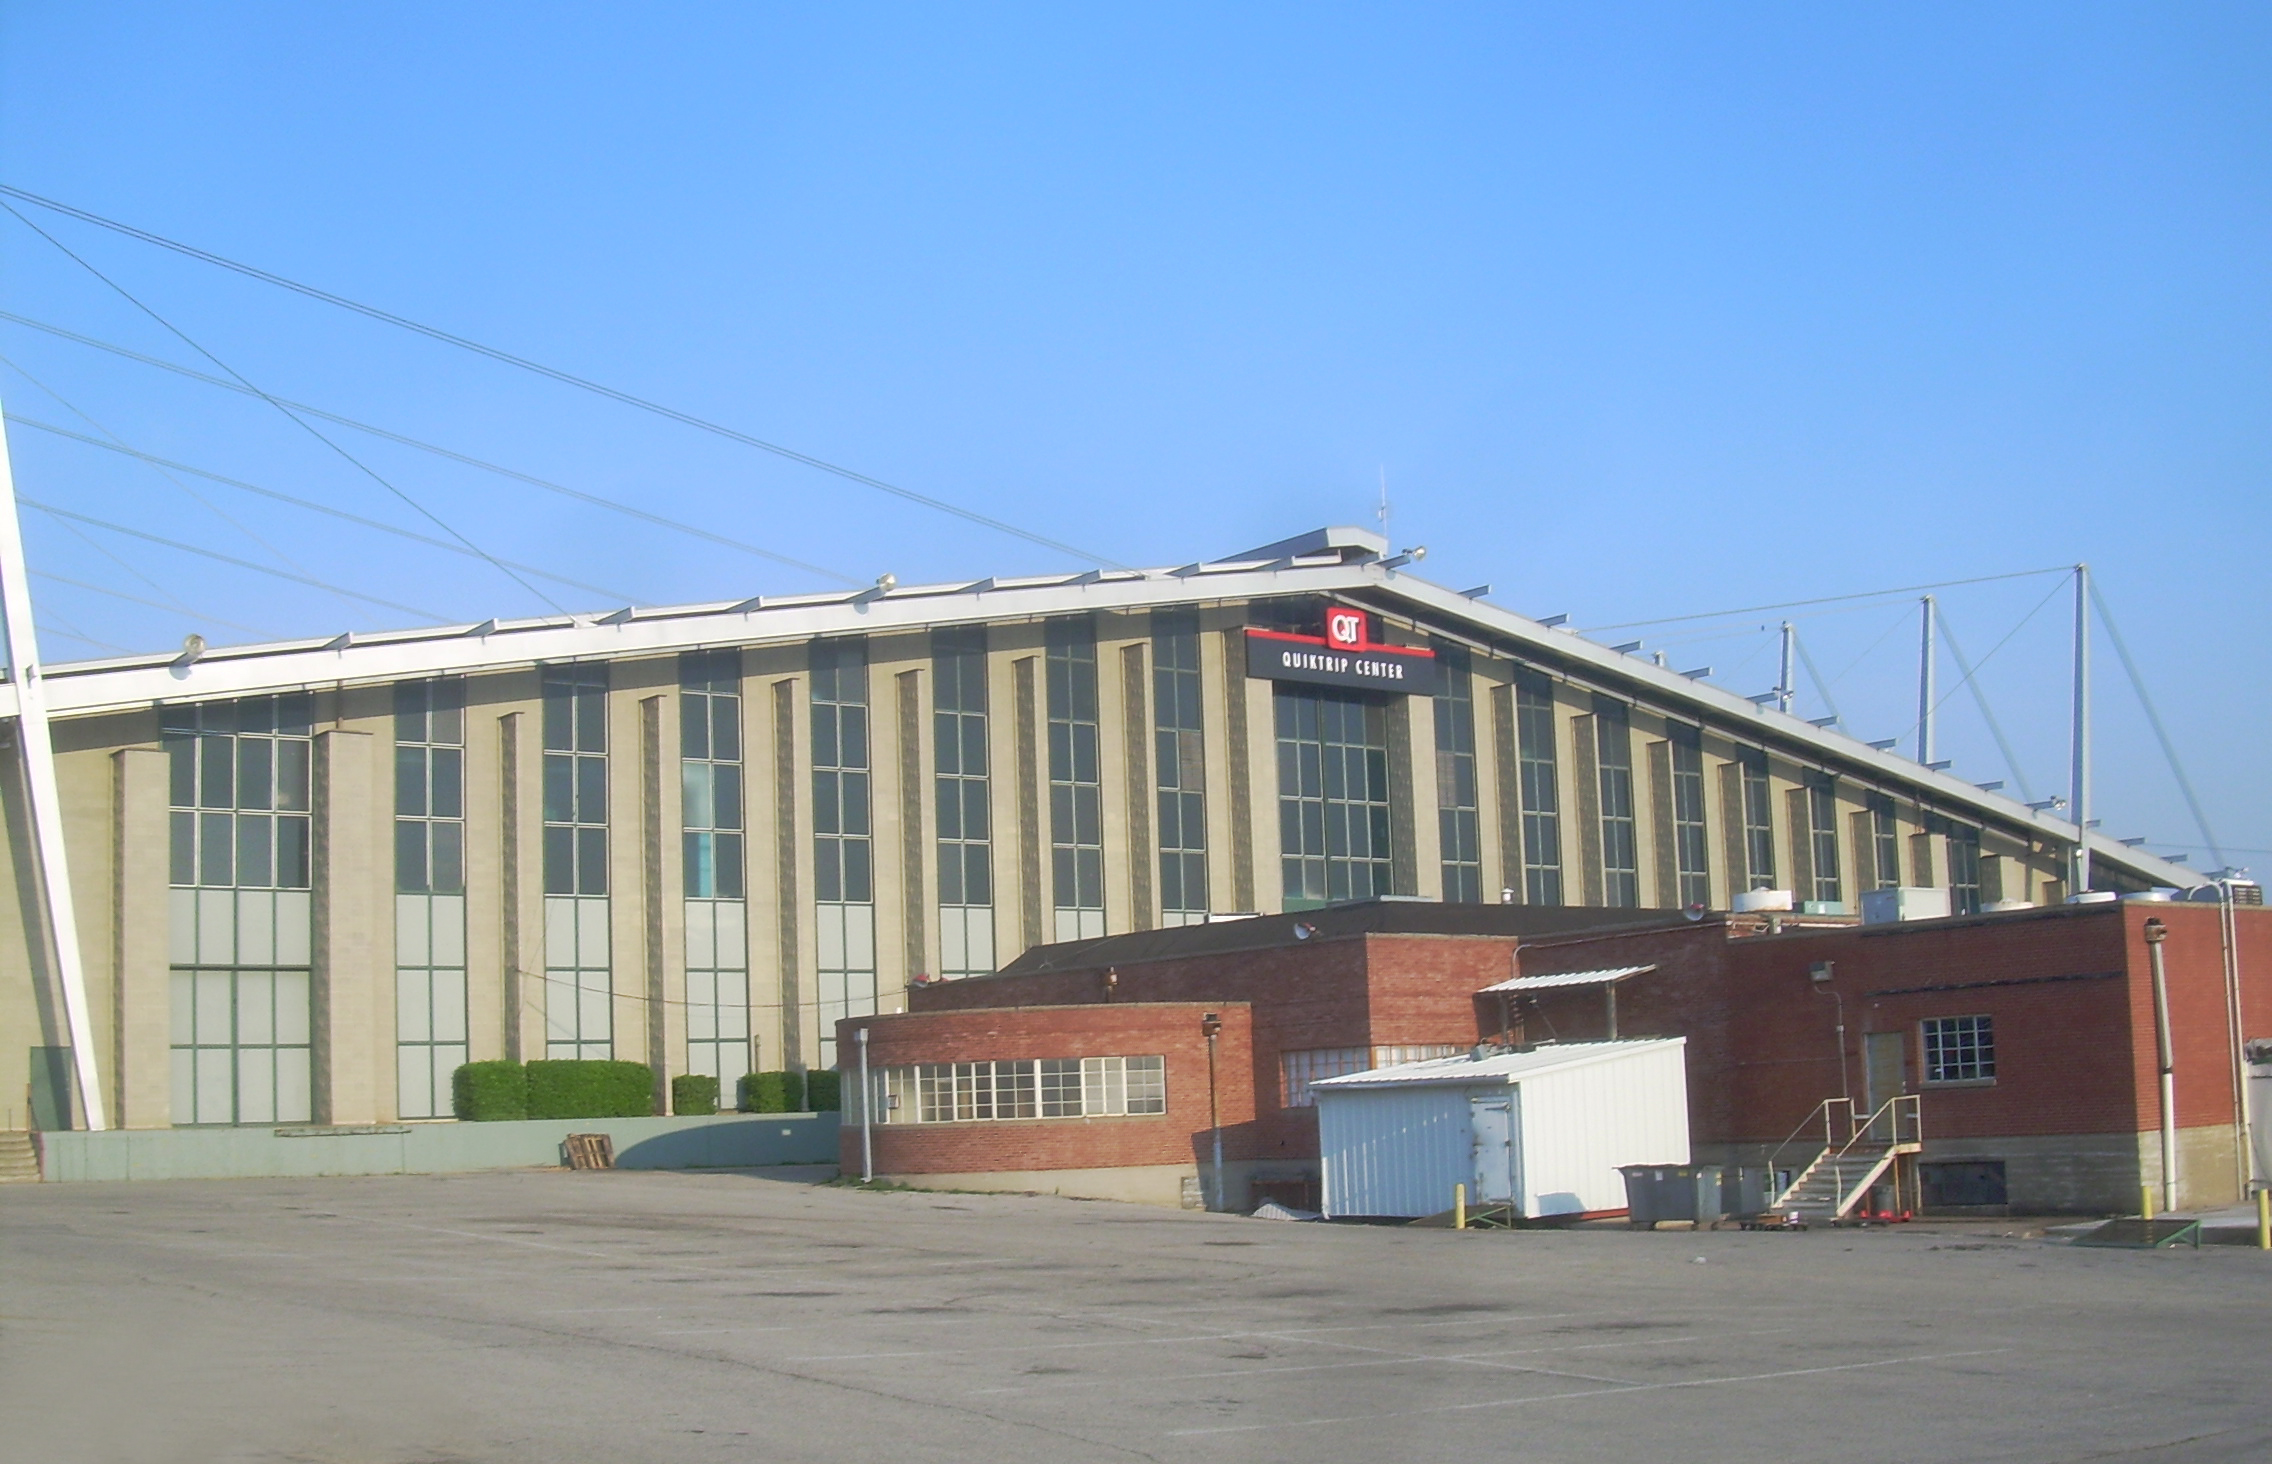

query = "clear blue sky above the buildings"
[0, 0, 2272, 866]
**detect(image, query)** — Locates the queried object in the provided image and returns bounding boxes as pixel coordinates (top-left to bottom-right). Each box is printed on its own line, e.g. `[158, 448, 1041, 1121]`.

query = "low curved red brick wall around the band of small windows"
[836, 1000, 1254, 1175]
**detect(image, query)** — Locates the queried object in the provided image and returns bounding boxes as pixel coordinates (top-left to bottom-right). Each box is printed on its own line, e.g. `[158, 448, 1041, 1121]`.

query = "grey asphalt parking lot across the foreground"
[0, 1171, 2272, 1464]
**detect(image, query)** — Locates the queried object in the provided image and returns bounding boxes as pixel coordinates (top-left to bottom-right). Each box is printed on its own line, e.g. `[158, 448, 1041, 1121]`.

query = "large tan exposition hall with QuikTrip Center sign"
[0, 530, 2199, 1128]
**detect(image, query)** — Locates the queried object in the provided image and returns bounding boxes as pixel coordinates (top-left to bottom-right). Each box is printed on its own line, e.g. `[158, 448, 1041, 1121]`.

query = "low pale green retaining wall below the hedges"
[41, 1114, 836, 1182]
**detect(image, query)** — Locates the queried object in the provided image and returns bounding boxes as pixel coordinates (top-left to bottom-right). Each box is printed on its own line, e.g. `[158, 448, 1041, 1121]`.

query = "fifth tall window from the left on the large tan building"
[813, 639, 877, 1066]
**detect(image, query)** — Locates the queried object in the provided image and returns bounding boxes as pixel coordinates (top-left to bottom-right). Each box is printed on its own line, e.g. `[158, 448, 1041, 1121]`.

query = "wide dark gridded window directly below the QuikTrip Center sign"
[1272, 682, 1395, 909]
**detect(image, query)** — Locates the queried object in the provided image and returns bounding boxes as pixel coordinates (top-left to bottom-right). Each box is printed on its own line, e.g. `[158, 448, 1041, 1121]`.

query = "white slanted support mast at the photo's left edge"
[0, 400, 109, 1130]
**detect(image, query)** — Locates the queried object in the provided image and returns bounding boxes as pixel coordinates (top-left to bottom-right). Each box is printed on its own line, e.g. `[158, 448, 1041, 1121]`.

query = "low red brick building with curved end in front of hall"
[843, 900, 2272, 1212]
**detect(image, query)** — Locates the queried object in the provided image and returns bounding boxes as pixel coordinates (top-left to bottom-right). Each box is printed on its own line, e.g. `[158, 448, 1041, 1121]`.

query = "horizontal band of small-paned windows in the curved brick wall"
[872, 1057, 1168, 1123]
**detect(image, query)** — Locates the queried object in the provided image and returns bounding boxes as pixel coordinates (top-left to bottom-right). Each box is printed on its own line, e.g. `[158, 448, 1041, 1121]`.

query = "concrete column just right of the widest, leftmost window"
[314, 730, 379, 1123]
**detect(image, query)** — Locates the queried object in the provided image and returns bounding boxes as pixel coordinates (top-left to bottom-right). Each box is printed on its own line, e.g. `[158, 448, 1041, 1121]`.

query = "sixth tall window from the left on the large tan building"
[932, 625, 995, 978]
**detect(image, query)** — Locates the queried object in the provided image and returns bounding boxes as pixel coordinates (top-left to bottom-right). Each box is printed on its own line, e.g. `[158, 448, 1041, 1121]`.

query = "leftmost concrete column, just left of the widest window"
[111, 748, 173, 1128]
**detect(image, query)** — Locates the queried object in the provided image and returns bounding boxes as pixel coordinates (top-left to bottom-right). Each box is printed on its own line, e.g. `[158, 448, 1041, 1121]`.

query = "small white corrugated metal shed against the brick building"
[1311, 1037, 1688, 1218]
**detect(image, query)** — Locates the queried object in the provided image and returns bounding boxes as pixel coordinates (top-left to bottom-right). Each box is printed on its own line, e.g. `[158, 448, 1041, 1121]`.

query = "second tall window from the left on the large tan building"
[395, 677, 466, 1118]
